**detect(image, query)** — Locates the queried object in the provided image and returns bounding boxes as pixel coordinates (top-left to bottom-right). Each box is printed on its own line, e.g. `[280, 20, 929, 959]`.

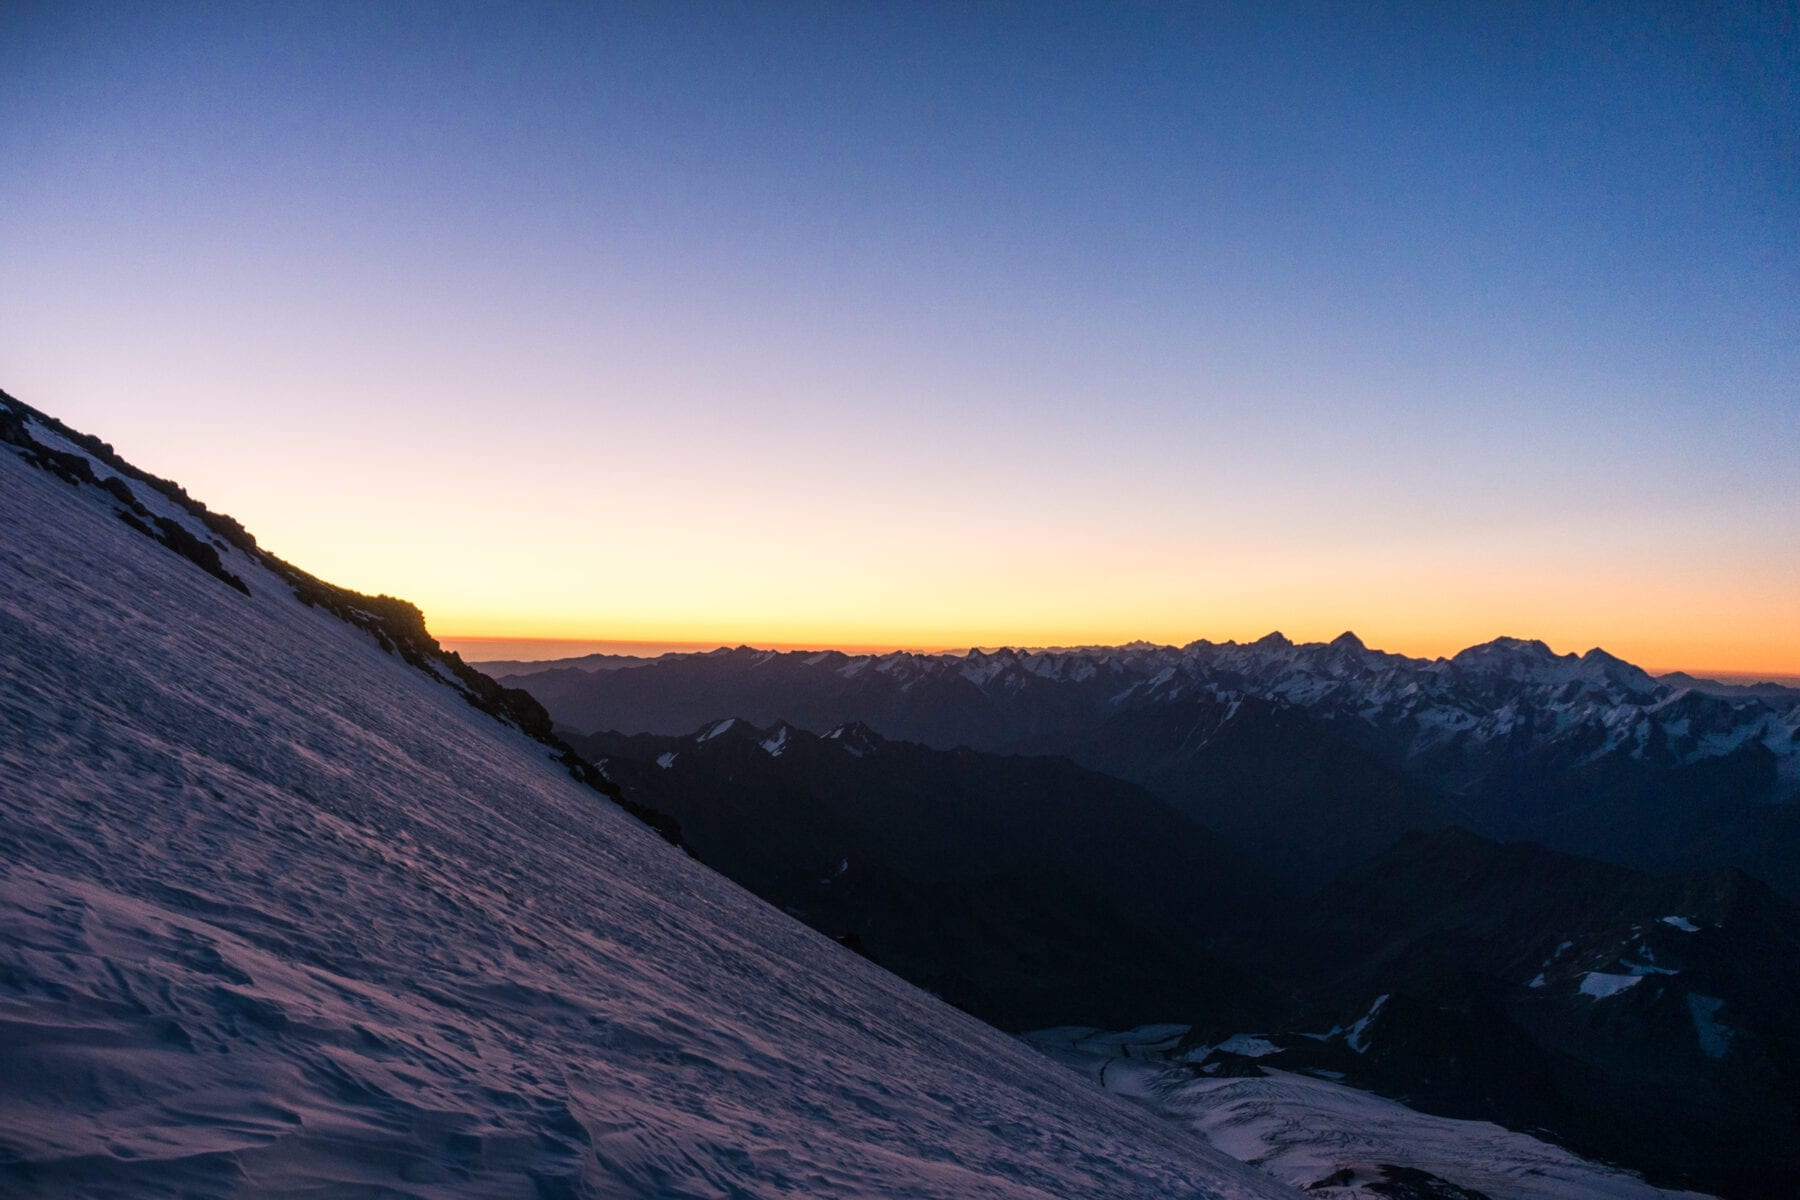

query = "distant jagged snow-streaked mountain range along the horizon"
[506, 633, 1800, 898]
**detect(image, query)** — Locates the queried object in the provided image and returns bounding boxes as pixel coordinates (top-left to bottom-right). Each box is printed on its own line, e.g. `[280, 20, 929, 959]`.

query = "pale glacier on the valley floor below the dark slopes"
[1026, 1025, 1701, 1200]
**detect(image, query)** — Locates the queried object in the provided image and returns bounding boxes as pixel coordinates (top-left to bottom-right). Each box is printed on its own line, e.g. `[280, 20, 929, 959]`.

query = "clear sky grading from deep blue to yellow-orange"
[0, 2, 1800, 673]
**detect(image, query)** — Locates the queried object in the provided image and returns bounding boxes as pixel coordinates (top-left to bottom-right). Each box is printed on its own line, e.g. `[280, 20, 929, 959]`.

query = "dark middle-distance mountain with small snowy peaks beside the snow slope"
[576, 720, 1271, 1029]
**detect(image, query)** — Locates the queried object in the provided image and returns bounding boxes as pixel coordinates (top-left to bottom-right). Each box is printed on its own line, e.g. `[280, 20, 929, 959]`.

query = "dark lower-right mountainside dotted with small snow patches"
[1238, 829, 1800, 1200]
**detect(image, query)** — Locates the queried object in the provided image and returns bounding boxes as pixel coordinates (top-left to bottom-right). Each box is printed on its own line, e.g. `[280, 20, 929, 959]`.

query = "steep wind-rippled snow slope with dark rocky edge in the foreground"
[0, 398, 1294, 1198]
